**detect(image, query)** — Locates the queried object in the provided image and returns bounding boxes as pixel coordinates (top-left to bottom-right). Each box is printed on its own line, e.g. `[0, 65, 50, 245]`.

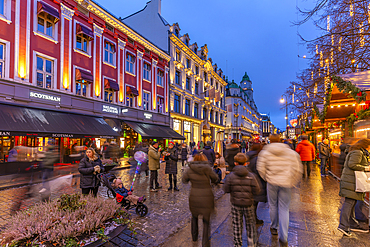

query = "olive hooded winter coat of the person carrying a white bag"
[339, 150, 369, 201]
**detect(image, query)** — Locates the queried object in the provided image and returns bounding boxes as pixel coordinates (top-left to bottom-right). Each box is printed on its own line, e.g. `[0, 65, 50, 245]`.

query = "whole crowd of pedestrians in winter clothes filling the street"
[74, 134, 370, 246]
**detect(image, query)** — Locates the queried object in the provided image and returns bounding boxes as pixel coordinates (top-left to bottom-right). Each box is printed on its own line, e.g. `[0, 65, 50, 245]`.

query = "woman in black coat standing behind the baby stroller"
[78, 148, 104, 197]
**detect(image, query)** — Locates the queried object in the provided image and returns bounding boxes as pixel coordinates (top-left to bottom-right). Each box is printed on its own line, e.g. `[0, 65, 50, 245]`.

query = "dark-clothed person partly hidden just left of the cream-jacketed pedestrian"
[247, 143, 267, 225]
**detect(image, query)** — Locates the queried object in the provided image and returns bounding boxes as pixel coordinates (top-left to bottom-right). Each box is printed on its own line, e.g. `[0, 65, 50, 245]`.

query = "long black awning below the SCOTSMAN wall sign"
[0, 104, 119, 138]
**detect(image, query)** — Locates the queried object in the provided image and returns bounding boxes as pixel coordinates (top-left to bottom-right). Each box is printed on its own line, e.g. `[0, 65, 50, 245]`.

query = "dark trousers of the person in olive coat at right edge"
[339, 197, 360, 231]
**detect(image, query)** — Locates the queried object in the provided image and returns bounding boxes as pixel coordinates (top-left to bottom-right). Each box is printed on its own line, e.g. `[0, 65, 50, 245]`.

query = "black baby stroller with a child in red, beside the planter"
[99, 173, 148, 217]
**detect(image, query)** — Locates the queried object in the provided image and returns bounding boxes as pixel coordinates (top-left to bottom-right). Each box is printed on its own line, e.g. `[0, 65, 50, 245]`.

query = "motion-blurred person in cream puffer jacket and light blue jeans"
[257, 134, 303, 246]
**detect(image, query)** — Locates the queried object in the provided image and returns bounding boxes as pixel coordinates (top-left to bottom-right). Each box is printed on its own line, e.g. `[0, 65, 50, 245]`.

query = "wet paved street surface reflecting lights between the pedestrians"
[0, 163, 370, 247]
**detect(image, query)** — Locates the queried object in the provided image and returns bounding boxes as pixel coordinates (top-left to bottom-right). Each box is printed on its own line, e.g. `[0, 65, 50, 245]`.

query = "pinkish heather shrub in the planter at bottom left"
[0, 194, 122, 246]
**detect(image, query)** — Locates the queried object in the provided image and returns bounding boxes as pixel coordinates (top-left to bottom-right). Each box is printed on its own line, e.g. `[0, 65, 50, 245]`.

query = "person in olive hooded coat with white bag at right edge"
[338, 139, 370, 236]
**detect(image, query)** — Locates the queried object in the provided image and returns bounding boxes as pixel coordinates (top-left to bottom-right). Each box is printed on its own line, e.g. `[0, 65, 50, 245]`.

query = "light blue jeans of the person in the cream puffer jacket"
[267, 183, 292, 242]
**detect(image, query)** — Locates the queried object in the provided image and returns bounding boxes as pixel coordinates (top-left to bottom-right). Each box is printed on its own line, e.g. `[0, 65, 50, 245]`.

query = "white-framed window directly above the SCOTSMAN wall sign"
[36, 56, 53, 88]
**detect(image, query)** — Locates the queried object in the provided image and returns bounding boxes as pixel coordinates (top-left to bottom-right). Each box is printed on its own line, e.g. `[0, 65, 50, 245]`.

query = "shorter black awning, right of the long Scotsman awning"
[124, 121, 185, 140]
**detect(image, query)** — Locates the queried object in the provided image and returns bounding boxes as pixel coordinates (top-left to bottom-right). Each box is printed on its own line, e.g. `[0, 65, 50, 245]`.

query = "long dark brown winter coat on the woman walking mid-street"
[182, 161, 218, 217]
